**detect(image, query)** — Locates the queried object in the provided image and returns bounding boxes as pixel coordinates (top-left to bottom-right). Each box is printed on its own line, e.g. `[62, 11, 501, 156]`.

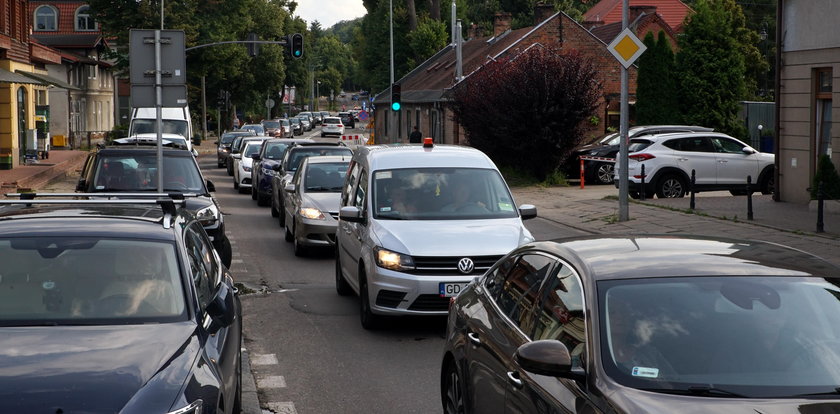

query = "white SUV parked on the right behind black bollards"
[615, 132, 775, 198]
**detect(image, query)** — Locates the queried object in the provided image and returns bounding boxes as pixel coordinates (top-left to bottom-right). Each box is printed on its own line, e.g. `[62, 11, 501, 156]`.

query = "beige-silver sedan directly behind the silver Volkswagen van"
[283, 154, 350, 256]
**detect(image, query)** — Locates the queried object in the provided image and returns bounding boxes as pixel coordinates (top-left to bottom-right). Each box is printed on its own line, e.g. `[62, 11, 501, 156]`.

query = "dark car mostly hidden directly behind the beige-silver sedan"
[271, 142, 353, 226]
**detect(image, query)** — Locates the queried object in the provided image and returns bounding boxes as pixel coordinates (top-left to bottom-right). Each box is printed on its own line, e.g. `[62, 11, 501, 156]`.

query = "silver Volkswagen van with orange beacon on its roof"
[335, 142, 537, 329]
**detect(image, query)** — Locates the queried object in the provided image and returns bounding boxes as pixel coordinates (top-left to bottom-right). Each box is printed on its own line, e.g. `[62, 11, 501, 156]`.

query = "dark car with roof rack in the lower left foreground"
[0, 194, 242, 414]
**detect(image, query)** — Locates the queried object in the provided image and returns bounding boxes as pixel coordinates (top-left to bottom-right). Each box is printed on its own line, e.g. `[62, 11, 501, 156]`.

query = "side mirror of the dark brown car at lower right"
[513, 339, 585, 380]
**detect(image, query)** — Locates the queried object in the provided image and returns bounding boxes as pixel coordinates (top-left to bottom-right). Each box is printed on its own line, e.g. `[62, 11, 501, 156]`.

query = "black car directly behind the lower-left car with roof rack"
[76, 146, 232, 266]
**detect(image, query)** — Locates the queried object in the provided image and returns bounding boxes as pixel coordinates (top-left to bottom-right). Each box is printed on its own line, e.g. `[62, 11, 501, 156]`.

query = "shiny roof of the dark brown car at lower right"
[517, 234, 840, 281]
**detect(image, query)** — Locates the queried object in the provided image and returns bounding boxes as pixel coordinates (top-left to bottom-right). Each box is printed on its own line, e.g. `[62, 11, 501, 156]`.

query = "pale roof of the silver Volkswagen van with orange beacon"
[356, 144, 497, 171]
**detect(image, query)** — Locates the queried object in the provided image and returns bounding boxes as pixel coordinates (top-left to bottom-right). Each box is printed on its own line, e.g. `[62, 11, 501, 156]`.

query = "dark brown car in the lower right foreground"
[440, 235, 840, 414]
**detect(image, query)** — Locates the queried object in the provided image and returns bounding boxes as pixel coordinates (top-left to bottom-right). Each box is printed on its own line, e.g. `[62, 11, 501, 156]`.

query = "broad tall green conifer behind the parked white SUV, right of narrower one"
[676, 0, 746, 137]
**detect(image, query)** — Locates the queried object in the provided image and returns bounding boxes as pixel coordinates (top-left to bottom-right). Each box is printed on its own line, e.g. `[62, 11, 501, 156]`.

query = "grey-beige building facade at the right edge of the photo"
[775, 0, 840, 203]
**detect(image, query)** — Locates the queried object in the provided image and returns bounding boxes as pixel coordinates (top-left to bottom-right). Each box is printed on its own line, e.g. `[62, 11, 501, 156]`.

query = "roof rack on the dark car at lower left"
[0, 193, 187, 229]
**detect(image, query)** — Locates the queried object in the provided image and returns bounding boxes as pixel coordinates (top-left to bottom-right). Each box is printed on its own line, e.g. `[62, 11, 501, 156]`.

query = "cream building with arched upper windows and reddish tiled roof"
[29, 0, 116, 144]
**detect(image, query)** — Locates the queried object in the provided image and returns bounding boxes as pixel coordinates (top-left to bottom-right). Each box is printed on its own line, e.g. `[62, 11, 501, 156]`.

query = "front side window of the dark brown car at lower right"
[525, 262, 586, 366]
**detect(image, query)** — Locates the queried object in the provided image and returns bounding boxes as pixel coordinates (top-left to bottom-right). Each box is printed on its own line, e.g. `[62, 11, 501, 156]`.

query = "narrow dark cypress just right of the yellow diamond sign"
[636, 31, 679, 125]
